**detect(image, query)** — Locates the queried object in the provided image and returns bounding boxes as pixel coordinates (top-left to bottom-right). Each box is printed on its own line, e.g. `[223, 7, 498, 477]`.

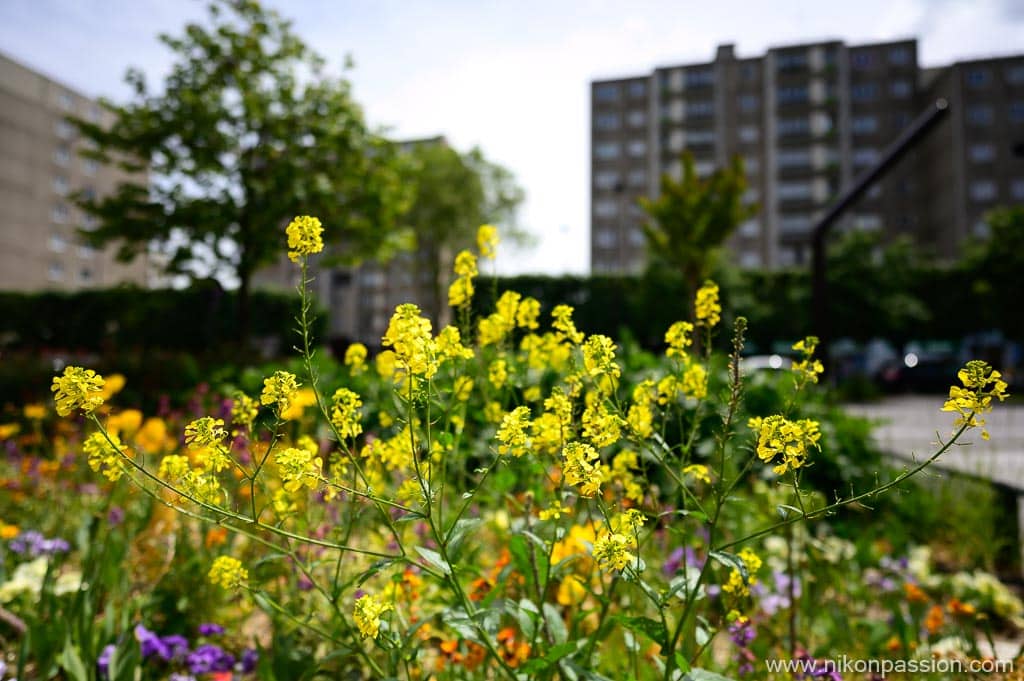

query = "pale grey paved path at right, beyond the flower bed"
[846, 395, 1024, 492]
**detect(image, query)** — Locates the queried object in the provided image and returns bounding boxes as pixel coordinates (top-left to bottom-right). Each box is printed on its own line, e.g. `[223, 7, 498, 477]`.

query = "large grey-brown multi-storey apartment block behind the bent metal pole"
[591, 40, 1024, 272]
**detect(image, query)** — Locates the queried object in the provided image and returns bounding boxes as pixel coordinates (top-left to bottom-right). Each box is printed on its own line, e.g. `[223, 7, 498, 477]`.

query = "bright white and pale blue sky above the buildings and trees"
[0, 0, 1024, 273]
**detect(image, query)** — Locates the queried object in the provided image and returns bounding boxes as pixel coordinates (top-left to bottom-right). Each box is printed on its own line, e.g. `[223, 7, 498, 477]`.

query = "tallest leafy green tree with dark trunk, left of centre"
[75, 0, 410, 342]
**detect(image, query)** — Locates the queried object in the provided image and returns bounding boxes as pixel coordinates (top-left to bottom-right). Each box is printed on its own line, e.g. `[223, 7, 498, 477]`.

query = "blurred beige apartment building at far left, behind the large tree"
[0, 49, 146, 291]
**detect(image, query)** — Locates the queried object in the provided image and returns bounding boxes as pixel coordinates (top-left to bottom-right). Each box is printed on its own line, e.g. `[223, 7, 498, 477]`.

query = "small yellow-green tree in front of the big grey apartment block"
[640, 152, 755, 311]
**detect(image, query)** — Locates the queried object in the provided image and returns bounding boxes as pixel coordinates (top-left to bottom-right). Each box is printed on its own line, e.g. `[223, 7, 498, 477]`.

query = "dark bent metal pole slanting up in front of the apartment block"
[811, 98, 949, 370]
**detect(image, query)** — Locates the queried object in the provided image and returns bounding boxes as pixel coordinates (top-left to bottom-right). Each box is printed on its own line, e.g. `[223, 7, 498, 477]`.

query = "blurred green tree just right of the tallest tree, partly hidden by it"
[404, 139, 523, 321]
